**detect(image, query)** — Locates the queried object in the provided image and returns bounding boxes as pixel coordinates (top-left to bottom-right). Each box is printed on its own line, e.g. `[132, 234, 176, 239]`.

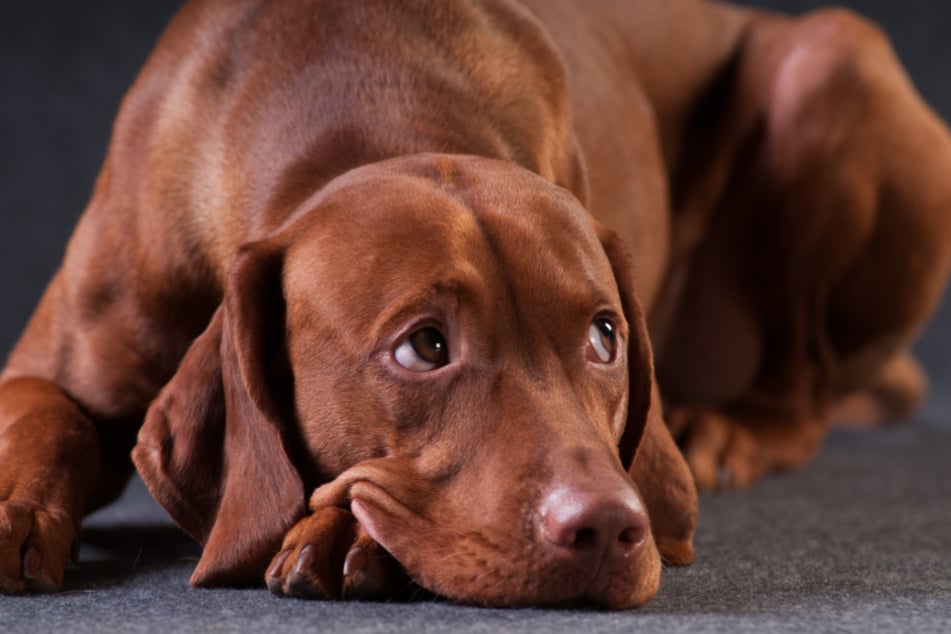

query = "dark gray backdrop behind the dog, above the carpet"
[0, 0, 951, 357]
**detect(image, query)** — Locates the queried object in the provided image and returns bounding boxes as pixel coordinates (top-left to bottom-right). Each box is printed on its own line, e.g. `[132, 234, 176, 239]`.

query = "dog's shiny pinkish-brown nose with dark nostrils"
[537, 481, 650, 566]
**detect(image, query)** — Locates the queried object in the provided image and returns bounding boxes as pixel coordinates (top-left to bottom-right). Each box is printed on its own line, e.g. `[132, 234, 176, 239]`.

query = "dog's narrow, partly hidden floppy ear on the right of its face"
[597, 226, 698, 564]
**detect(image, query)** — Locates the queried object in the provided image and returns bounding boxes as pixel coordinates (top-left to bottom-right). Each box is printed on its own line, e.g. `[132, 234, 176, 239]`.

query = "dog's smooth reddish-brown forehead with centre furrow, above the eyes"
[289, 161, 617, 310]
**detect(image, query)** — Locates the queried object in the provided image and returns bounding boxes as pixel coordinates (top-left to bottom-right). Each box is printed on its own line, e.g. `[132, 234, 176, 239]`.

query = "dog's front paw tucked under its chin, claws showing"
[266, 507, 411, 601]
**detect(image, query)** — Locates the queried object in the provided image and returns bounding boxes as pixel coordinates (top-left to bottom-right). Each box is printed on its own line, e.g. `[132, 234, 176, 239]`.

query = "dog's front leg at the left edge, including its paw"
[0, 205, 212, 592]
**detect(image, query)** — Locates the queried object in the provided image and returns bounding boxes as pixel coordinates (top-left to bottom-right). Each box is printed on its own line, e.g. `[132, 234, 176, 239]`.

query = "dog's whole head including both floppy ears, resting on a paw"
[135, 156, 696, 607]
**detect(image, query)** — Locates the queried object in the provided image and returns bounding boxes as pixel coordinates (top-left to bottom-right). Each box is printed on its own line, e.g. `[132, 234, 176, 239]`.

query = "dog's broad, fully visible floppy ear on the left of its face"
[132, 242, 305, 586]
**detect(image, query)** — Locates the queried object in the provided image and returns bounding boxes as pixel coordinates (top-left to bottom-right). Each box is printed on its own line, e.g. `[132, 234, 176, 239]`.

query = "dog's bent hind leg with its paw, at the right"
[661, 11, 951, 487]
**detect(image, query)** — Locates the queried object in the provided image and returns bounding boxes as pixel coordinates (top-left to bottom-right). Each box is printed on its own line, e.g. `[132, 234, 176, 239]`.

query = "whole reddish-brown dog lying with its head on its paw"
[0, 0, 951, 608]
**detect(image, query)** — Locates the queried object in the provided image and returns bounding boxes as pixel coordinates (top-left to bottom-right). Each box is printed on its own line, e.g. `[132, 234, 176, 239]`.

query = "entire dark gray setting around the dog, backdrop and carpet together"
[0, 0, 951, 632]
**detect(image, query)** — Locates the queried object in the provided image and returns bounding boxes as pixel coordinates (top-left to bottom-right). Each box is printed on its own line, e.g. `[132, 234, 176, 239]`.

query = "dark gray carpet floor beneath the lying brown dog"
[0, 420, 951, 634]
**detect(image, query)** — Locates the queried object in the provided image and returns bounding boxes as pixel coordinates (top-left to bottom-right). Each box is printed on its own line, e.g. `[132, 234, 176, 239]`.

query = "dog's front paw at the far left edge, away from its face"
[0, 500, 77, 593]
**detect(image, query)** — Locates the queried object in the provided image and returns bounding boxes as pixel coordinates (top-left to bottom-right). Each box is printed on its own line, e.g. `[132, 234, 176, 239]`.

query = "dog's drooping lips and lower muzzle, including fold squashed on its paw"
[310, 458, 660, 609]
